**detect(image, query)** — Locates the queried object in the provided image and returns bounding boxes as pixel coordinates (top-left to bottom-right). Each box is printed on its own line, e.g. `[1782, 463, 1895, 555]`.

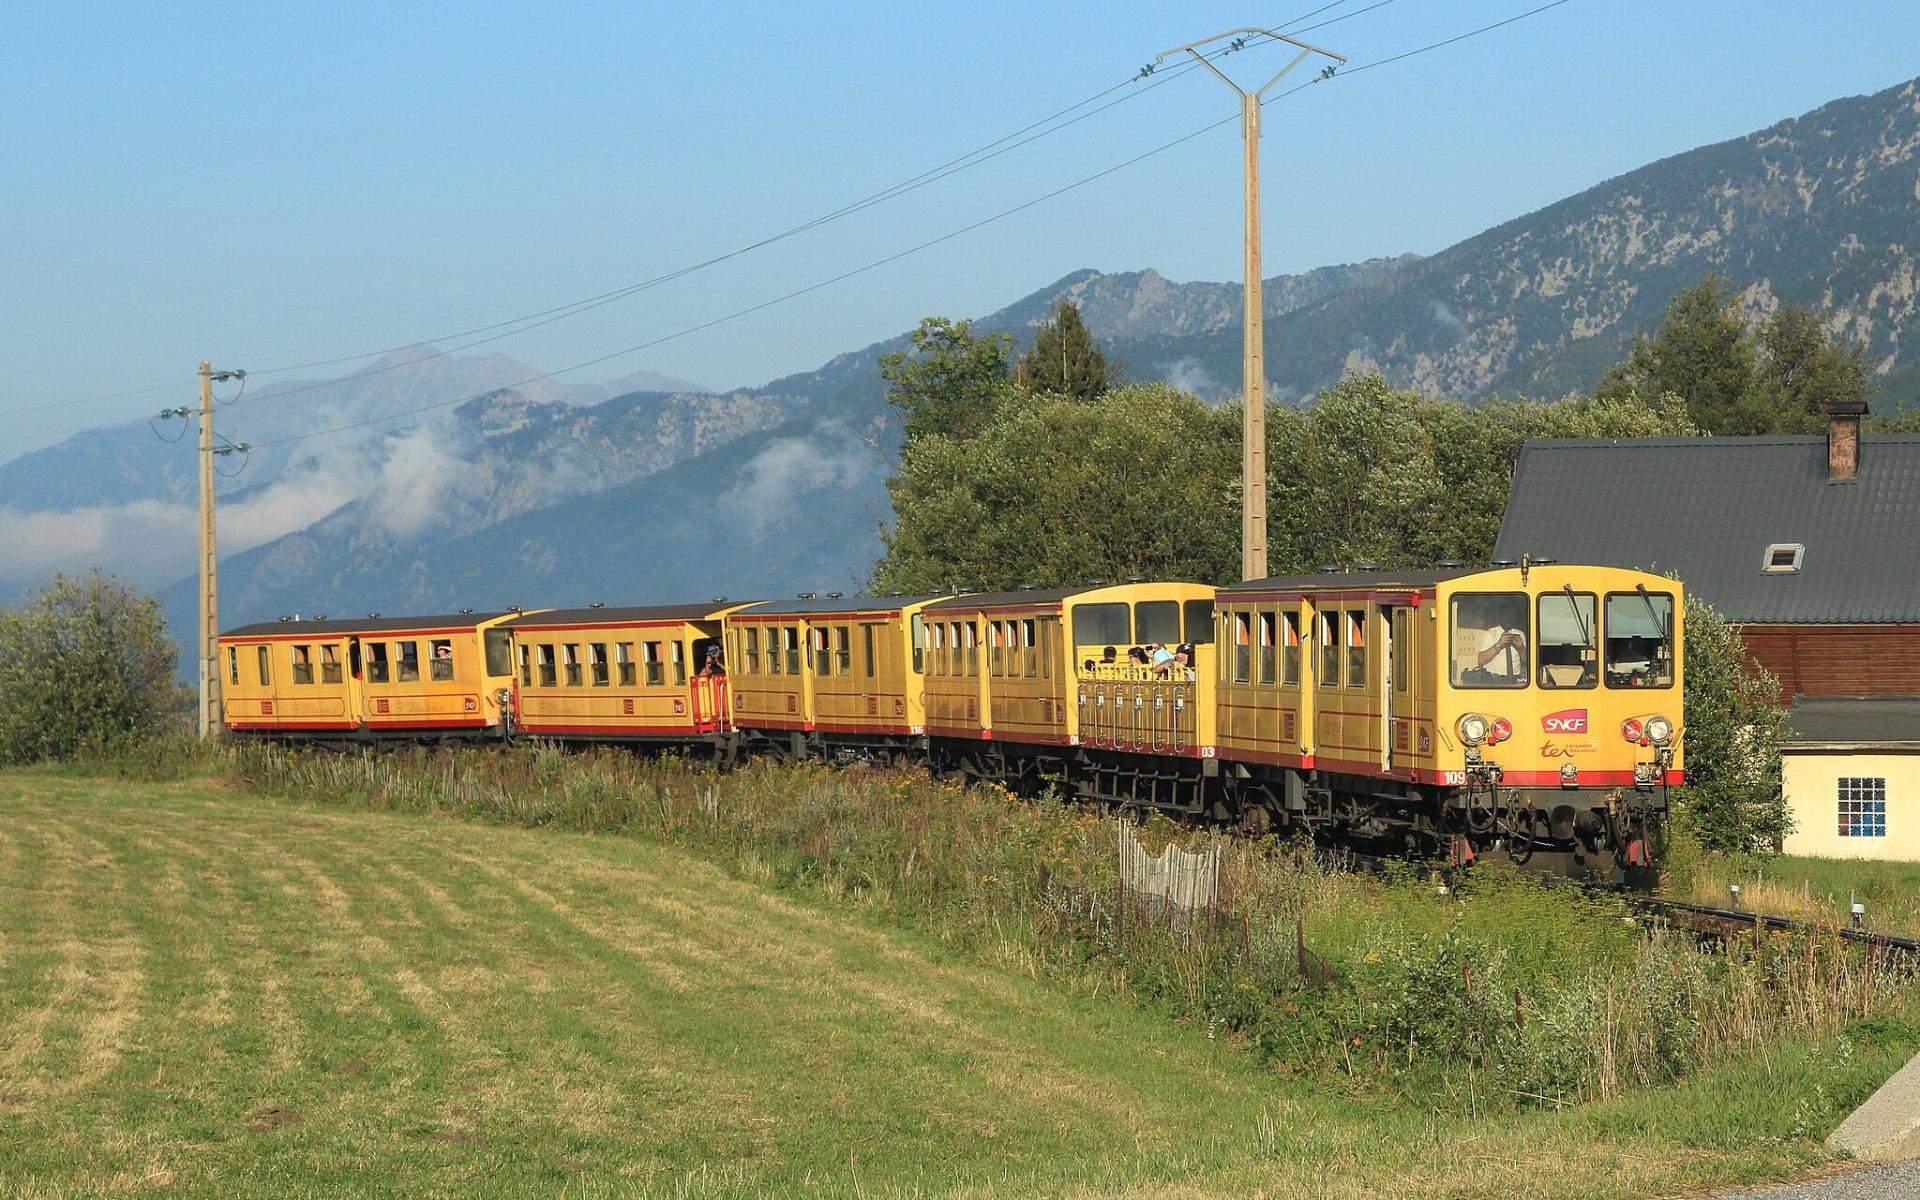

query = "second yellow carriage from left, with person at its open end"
[505, 601, 741, 745]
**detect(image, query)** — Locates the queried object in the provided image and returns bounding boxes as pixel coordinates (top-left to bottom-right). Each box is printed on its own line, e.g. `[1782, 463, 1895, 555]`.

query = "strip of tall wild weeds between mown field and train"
[224, 747, 1916, 1104]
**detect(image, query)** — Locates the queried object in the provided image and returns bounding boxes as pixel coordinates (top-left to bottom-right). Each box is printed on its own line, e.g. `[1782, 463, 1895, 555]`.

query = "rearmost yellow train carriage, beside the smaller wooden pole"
[219, 612, 515, 739]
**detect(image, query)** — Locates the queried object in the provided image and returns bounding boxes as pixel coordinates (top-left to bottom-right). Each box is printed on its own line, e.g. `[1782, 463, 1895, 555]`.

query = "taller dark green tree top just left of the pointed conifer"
[879, 317, 1014, 444]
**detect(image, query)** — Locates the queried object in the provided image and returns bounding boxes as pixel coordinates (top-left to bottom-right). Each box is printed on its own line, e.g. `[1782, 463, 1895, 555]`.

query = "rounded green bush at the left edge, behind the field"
[0, 570, 177, 762]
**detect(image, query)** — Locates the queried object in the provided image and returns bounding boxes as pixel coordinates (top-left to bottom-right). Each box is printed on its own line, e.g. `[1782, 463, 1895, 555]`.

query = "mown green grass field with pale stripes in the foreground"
[0, 772, 1903, 1200]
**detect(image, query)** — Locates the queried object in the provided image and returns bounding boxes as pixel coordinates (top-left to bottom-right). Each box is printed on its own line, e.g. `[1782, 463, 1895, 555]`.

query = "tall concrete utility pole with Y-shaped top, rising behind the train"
[1154, 27, 1346, 580]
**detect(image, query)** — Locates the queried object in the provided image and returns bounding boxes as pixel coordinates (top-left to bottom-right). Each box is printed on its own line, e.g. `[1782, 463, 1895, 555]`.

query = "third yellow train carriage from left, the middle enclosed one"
[726, 595, 937, 753]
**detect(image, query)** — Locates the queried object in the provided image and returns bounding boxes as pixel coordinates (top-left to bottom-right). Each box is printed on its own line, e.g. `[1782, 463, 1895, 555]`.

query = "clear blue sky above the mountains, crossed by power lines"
[0, 0, 1920, 459]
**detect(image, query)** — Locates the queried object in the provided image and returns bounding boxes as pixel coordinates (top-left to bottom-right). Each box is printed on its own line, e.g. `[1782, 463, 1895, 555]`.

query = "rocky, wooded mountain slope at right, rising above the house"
[1121, 83, 1920, 401]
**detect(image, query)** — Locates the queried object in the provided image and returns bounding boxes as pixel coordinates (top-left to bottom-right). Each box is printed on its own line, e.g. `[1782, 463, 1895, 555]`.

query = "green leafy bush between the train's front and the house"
[1674, 595, 1791, 852]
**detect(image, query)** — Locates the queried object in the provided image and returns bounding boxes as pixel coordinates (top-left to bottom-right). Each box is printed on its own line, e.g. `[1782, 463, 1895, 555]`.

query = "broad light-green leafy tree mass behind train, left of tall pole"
[874, 384, 1240, 591]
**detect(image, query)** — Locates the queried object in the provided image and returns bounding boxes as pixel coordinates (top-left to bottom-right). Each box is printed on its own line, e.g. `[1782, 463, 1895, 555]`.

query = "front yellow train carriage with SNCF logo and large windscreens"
[1217, 563, 1684, 870]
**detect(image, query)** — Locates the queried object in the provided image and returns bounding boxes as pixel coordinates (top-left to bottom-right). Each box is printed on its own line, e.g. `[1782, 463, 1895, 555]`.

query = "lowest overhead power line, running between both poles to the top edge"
[253, 0, 1571, 449]
